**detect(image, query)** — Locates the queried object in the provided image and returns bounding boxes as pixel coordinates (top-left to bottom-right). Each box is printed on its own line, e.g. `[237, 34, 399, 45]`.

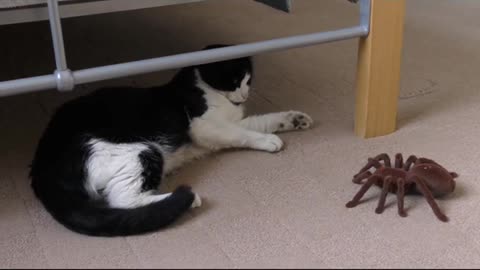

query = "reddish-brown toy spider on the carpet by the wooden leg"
[346, 154, 458, 222]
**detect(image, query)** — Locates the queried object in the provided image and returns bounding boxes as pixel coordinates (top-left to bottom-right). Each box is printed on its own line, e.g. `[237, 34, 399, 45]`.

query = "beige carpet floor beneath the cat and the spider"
[0, 0, 480, 268]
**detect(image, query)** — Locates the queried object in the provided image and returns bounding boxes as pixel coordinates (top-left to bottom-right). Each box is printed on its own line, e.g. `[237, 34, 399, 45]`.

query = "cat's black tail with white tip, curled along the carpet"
[41, 186, 200, 236]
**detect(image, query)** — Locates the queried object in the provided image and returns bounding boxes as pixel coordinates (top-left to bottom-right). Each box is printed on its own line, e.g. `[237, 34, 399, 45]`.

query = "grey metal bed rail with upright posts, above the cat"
[0, 0, 371, 97]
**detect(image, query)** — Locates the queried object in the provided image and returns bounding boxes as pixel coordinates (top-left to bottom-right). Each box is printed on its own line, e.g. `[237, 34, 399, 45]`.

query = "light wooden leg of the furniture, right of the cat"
[355, 0, 405, 138]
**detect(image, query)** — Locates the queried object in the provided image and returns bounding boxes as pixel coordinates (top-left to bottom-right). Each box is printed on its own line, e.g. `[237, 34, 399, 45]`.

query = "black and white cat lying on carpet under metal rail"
[30, 45, 312, 236]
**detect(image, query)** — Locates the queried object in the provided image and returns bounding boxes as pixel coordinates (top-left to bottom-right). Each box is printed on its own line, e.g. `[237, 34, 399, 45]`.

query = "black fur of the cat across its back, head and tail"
[30, 45, 251, 236]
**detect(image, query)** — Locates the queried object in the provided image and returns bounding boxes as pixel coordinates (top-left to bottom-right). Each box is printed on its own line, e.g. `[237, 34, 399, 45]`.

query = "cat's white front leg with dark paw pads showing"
[239, 111, 313, 133]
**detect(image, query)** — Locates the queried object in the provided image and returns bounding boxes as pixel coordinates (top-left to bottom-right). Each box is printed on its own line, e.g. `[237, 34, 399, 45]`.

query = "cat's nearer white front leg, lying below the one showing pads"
[190, 118, 283, 152]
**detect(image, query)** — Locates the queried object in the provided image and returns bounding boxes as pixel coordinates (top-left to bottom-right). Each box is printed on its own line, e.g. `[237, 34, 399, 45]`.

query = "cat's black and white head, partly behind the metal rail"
[196, 45, 253, 105]
